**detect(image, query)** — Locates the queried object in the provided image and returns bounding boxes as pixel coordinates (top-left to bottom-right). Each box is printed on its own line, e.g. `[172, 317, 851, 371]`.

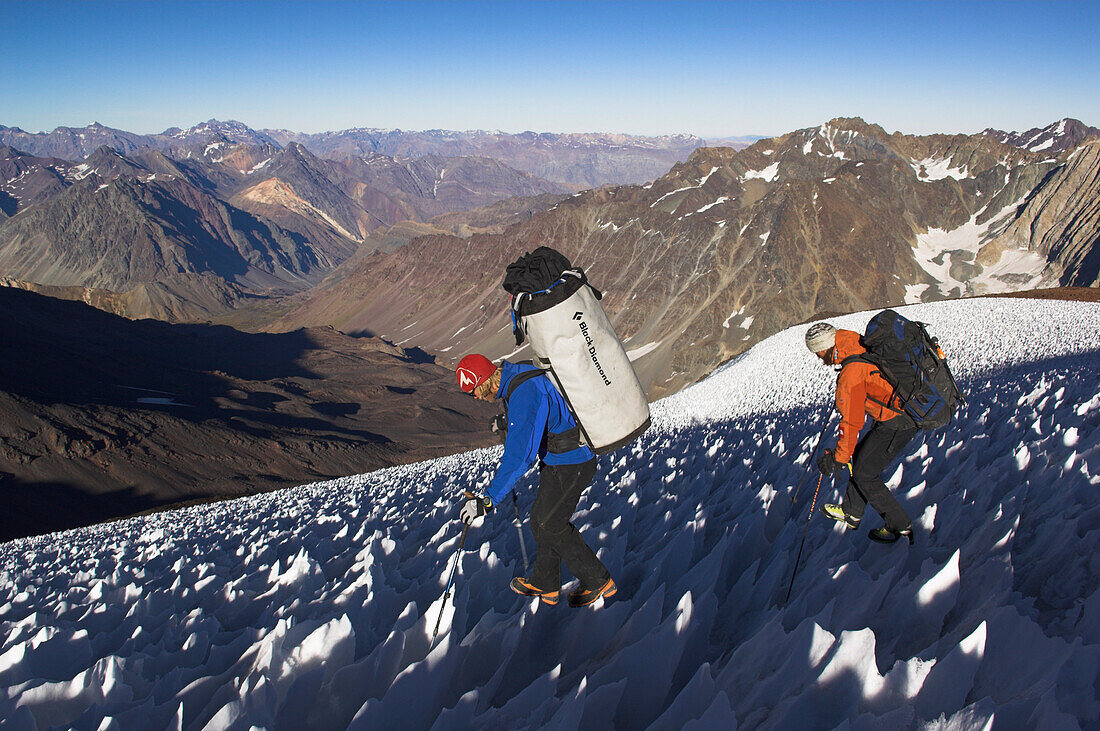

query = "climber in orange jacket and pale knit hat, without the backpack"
[806, 322, 917, 543]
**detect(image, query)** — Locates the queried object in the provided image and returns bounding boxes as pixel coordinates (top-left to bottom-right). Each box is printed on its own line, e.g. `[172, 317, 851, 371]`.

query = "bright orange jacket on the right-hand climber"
[833, 330, 901, 464]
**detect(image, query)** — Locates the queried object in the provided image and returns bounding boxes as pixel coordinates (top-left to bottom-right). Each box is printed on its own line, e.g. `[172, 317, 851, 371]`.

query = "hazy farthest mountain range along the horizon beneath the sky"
[0, 120, 730, 190]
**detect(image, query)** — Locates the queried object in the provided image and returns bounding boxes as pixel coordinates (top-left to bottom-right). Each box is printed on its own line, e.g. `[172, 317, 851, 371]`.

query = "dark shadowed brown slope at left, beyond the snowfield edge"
[0, 287, 495, 541]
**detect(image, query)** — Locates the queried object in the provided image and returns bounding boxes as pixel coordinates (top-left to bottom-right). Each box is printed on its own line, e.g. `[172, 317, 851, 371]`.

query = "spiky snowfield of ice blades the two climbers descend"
[0, 299, 1100, 730]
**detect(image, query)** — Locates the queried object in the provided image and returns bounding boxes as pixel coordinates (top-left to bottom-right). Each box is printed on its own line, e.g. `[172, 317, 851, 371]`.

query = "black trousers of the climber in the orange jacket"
[844, 417, 917, 531]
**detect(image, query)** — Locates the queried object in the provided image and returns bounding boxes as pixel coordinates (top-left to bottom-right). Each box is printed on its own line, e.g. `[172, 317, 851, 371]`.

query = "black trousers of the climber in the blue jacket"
[528, 459, 611, 590]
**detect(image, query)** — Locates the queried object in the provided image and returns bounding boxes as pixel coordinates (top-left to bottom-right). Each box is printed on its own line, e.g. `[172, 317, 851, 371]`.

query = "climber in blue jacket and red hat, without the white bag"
[455, 354, 616, 607]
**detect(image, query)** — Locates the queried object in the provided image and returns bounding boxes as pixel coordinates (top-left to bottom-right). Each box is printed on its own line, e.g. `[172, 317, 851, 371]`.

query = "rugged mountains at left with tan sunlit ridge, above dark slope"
[0, 134, 565, 320]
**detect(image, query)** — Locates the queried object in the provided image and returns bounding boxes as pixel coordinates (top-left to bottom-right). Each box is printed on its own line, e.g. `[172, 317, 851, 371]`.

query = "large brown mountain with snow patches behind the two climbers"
[268, 120, 1100, 396]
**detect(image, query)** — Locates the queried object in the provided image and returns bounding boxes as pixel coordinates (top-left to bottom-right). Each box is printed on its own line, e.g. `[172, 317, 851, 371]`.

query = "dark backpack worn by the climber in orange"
[844, 310, 966, 429]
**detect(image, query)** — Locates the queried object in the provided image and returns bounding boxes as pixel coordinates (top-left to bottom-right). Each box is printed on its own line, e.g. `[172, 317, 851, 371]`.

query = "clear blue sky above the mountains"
[0, 0, 1100, 137]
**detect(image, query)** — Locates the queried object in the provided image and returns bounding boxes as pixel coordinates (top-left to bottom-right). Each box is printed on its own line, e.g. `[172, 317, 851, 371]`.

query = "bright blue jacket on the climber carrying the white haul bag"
[486, 361, 595, 505]
